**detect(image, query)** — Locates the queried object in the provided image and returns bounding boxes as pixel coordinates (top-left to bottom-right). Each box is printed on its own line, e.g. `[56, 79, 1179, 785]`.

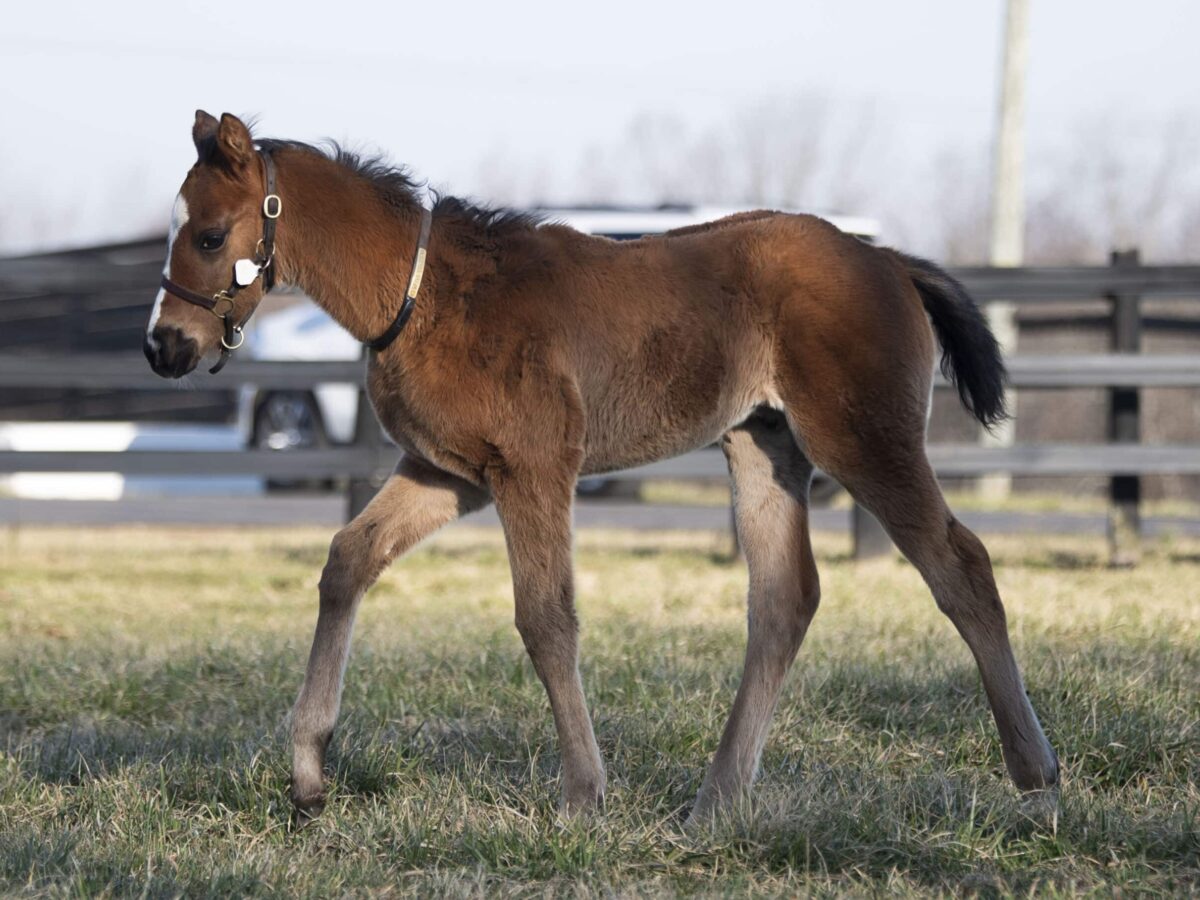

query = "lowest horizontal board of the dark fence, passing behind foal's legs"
[0, 444, 1200, 481]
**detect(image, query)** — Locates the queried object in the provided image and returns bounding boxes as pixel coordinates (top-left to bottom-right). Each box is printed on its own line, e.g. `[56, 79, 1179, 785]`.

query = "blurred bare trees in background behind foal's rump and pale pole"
[468, 94, 1200, 274]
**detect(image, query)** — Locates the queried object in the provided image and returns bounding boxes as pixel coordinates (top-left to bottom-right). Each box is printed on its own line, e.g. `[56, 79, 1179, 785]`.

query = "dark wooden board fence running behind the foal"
[0, 254, 1200, 558]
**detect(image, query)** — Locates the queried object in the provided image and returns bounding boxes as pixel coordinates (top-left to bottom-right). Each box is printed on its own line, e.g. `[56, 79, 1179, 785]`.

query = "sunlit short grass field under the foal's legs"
[0, 529, 1200, 896]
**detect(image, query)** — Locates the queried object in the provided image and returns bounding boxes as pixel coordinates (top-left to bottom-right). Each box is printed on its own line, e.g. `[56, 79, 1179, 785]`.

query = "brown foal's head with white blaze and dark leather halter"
[144, 110, 277, 378]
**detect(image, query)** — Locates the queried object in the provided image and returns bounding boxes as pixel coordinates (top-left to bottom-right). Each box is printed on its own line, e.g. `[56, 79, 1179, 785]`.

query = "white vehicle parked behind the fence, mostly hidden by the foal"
[239, 205, 878, 481]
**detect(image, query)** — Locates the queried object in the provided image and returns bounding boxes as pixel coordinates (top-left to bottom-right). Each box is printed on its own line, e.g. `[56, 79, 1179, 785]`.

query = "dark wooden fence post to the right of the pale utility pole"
[1108, 250, 1141, 566]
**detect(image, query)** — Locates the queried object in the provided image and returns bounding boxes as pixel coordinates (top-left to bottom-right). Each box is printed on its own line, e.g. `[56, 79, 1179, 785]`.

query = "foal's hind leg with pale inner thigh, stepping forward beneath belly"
[691, 413, 821, 821]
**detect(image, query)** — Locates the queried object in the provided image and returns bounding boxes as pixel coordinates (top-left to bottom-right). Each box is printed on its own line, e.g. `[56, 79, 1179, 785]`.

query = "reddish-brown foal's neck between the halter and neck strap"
[276, 150, 426, 341]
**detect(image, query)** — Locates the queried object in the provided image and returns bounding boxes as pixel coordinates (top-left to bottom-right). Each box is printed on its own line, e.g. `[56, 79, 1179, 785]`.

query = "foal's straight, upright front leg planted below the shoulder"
[490, 472, 605, 816]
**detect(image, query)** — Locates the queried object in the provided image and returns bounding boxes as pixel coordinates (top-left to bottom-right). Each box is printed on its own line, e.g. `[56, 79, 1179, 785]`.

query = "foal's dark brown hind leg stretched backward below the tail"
[788, 412, 1058, 791]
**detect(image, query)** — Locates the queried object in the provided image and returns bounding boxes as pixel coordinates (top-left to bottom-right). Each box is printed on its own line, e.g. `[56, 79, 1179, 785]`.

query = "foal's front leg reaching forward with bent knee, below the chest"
[292, 456, 487, 816]
